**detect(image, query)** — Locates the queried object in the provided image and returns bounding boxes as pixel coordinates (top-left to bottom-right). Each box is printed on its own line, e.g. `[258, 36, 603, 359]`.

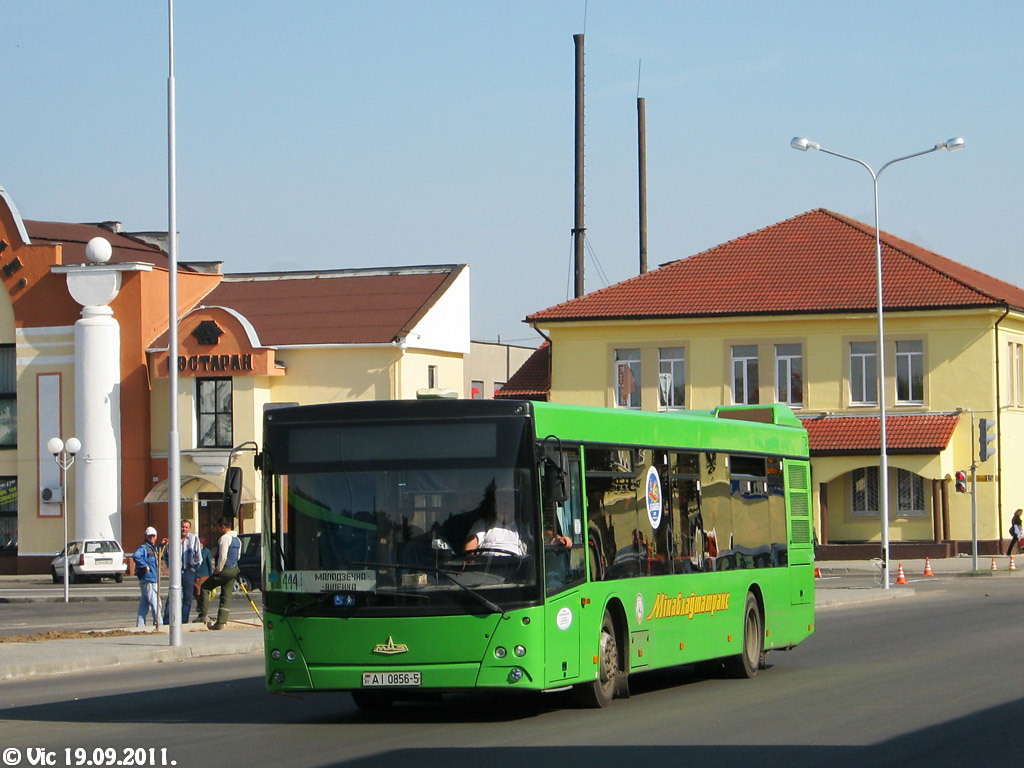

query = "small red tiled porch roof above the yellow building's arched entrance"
[801, 414, 959, 457]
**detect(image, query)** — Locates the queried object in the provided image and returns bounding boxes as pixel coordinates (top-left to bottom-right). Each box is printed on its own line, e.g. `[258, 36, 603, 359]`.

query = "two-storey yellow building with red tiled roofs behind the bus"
[526, 209, 1024, 557]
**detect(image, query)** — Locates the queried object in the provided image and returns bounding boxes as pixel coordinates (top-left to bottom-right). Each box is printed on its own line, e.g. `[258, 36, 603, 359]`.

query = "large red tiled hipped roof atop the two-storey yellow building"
[526, 208, 1024, 322]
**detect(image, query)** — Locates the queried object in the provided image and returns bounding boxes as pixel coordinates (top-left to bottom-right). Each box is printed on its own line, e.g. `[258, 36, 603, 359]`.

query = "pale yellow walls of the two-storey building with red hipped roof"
[539, 309, 1024, 541]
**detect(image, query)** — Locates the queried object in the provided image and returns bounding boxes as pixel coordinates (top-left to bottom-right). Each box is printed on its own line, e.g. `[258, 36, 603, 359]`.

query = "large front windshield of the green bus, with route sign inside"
[266, 419, 540, 611]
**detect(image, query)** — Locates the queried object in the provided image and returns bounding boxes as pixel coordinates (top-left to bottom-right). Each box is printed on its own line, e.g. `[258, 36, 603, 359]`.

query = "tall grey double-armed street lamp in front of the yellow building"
[790, 136, 964, 589]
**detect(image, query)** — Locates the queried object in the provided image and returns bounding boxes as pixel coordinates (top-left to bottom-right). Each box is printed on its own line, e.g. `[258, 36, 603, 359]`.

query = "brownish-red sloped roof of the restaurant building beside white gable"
[203, 264, 465, 346]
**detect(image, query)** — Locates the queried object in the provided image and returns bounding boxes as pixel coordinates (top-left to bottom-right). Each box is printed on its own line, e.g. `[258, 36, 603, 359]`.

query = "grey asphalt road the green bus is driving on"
[0, 578, 1024, 768]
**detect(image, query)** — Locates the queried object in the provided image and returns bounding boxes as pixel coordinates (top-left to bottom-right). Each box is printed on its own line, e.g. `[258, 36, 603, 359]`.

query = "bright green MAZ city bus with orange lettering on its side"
[257, 400, 814, 710]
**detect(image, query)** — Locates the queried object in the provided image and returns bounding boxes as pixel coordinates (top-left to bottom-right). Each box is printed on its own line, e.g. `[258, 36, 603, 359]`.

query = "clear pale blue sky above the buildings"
[0, 0, 1024, 344]
